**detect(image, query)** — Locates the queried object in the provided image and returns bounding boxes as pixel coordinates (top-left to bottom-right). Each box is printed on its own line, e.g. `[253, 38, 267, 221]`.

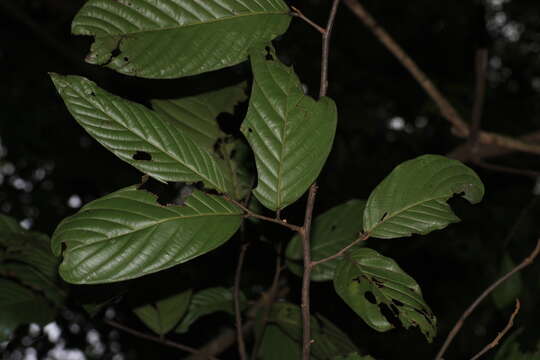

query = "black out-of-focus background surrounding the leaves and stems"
[0, 0, 540, 360]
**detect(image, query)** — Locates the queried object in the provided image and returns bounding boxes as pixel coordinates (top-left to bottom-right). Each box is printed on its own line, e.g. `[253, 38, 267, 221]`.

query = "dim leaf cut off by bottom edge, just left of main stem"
[259, 324, 302, 360]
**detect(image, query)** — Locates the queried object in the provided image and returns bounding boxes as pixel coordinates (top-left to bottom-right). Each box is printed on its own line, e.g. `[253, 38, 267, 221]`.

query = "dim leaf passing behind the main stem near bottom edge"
[268, 302, 358, 360]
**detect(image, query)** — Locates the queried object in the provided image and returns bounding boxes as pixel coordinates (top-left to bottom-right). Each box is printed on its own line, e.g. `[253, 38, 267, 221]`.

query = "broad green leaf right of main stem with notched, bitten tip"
[364, 155, 484, 239]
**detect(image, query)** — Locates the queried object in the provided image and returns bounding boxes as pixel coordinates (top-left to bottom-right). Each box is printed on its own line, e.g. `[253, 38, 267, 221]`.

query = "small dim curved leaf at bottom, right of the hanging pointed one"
[175, 287, 246, 334]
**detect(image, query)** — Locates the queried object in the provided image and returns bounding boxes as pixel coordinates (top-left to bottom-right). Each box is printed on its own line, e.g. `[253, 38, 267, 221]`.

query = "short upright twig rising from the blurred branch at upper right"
[469, 48, 488, 153]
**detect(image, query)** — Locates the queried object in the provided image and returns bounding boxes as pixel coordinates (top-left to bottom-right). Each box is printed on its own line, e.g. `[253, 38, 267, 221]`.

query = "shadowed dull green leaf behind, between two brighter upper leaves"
[151, 83, 247, 151]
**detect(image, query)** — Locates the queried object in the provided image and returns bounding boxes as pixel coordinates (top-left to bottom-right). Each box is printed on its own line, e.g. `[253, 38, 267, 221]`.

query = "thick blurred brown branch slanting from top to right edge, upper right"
[344, 0, 540, 154]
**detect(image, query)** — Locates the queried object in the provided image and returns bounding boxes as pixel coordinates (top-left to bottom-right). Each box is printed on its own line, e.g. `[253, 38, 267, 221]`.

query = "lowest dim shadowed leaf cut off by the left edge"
[0, 278, 56, 342]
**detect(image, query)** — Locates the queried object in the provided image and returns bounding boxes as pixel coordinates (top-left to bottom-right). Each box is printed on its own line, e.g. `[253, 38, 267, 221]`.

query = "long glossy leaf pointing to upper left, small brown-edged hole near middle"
[51, 73, 230, 192]
